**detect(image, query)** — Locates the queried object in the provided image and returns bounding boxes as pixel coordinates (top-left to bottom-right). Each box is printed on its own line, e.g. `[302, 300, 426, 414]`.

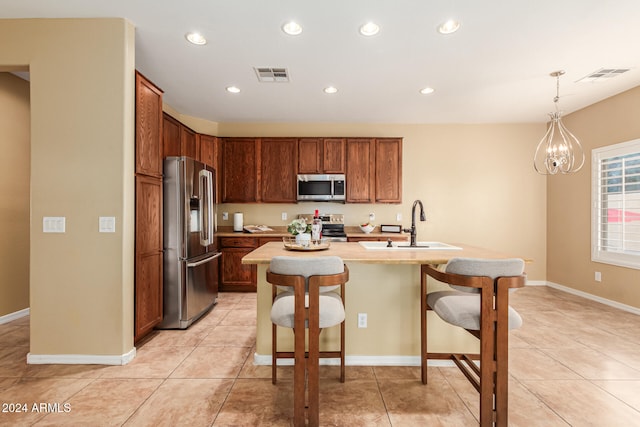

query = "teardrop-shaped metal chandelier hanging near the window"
[533, 70, 584, 175]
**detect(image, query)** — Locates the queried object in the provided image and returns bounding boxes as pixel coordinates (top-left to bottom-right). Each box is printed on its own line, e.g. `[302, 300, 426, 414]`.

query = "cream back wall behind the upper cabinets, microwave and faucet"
[218, 123, 546, 280]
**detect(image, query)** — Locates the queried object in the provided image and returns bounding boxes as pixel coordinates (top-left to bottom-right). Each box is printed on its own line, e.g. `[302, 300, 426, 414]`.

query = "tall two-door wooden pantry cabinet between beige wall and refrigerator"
[134, 72, 163, 342]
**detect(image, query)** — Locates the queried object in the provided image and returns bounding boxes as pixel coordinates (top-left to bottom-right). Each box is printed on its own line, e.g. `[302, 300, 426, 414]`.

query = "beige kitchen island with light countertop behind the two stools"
[242, 242, 524, 366]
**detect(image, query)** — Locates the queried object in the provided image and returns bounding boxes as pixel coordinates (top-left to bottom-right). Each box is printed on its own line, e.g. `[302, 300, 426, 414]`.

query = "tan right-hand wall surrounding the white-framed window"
[547, 87, 640, 307]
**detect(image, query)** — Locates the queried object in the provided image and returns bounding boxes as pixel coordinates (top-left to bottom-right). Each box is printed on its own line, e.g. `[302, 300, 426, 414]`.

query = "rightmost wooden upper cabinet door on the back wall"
[375, 138, 402, 203]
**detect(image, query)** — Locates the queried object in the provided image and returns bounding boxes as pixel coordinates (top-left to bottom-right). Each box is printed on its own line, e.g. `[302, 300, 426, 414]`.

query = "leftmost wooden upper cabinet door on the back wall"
[220, 138, 260, 203]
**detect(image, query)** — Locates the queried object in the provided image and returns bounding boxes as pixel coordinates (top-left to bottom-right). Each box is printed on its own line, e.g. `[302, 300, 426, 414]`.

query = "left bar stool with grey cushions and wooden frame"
[267, 256, 349, 426]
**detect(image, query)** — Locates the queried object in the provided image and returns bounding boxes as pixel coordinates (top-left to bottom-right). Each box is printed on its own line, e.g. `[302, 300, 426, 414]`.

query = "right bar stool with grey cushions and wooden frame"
[420, 258, 525, 427]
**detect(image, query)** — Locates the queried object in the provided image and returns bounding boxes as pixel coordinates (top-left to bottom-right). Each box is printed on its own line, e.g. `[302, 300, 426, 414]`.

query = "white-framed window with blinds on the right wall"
[591, 139, 640, 269]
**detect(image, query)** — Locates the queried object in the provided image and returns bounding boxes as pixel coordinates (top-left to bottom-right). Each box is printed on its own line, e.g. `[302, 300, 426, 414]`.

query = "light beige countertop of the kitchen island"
[242, 242, 512, 264]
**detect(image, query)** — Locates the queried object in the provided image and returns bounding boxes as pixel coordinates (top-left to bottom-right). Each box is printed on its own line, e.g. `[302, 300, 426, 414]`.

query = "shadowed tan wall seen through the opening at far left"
[0, 73, 30, 316]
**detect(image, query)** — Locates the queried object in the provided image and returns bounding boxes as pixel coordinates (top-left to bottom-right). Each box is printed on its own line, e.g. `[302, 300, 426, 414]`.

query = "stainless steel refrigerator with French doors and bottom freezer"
[158, 157, 220, 329]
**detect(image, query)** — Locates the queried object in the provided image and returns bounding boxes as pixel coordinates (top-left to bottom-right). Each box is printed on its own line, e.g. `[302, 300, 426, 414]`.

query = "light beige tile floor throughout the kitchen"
[0, 287, 640, 427]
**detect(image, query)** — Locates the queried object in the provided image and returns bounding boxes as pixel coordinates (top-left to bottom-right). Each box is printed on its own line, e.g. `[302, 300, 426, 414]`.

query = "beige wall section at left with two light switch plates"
[0, 19, 135, 356]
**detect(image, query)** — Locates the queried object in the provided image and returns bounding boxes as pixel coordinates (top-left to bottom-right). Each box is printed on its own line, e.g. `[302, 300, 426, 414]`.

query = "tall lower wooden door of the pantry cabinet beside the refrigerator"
[134, 175, 163, 340]
